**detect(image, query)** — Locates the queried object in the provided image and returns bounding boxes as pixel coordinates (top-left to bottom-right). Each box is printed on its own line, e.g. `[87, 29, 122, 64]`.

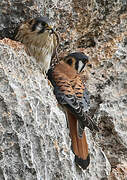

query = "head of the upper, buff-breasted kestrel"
[28, 16, 54, 34]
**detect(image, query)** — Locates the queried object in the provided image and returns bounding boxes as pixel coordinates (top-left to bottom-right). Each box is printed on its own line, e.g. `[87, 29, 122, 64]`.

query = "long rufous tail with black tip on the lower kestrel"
[67, 111, 90, 169]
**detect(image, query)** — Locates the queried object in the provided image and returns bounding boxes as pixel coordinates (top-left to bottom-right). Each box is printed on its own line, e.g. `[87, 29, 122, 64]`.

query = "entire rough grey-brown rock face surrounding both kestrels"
[0, 0, 127, 180]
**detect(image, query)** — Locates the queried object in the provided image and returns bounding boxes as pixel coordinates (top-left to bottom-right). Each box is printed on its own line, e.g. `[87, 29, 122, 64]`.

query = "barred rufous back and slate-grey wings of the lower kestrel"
[48, 64, 98, 137]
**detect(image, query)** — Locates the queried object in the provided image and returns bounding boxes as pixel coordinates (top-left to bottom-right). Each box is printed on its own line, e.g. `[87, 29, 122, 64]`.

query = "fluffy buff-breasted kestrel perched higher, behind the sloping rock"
[15, 17, 59, 74]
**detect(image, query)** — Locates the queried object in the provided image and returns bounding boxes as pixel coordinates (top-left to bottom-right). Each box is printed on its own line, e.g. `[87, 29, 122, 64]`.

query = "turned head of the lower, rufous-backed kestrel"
[64, 52, 88, 73]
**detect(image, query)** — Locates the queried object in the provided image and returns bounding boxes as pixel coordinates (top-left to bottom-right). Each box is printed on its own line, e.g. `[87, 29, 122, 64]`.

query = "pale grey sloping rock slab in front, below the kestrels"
[0, 39, 110, 180]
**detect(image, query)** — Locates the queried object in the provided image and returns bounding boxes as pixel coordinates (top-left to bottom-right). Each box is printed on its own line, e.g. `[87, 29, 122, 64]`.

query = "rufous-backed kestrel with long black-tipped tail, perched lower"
[48, 52, 98, 169]
